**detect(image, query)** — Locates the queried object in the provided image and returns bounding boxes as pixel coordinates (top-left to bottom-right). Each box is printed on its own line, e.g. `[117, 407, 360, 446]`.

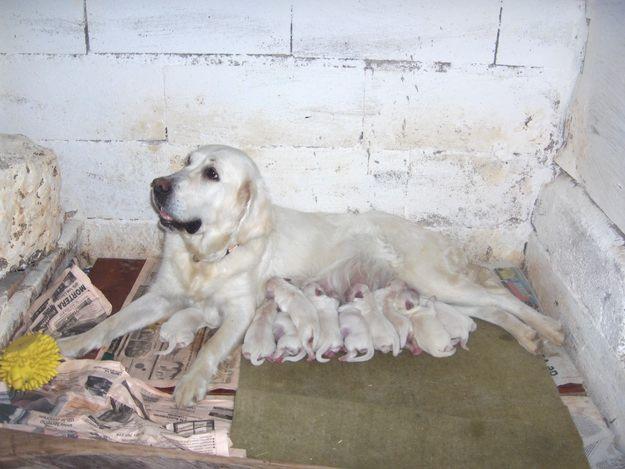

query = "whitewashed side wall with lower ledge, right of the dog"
[526, 0, 625, 450]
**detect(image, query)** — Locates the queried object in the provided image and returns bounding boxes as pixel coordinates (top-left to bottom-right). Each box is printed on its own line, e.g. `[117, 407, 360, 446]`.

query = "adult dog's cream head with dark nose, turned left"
[152, 145, 269, 249]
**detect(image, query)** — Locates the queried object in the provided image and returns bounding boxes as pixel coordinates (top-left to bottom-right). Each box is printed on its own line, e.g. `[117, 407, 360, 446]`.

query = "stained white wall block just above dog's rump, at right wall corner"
[406, 152, 551, 229]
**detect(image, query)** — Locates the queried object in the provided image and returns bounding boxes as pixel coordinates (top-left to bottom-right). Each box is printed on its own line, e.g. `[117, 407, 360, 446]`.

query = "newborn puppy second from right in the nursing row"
[407, 298, 456, 358]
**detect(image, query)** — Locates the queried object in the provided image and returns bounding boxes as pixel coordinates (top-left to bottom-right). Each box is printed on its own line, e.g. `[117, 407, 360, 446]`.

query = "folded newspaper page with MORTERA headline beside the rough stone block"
[15, 264, 112, 338]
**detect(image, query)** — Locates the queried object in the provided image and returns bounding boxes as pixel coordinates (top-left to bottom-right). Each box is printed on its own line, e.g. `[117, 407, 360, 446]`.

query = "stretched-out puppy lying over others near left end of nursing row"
[266, 277, 319, 360]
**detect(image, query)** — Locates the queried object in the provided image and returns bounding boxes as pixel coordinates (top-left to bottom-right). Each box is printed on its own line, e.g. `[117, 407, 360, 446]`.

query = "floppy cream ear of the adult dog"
[236, 179, 271, 244]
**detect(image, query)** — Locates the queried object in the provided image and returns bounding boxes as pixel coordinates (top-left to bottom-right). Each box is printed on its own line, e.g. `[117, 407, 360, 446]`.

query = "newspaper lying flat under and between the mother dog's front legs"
[98, 259, 241, 391]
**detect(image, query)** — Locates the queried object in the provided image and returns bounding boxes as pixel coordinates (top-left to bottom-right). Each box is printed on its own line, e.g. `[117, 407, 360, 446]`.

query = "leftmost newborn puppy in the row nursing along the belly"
[241, 300, 278, 366]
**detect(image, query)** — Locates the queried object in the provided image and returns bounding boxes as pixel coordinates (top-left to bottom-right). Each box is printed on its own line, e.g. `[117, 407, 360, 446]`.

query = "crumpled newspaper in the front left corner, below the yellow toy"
[0, 360, 233, 456]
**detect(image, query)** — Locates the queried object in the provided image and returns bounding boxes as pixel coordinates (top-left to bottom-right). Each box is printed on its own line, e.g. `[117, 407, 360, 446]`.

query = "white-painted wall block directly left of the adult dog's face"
[46, 142, 191, 222]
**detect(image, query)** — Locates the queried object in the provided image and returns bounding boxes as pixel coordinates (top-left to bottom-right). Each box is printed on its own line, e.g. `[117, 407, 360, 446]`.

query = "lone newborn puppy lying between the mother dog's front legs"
[156, 307, 221, 355]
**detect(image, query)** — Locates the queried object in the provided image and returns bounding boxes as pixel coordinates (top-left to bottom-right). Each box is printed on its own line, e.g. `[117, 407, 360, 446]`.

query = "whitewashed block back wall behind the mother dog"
[0, 0, 586, 261]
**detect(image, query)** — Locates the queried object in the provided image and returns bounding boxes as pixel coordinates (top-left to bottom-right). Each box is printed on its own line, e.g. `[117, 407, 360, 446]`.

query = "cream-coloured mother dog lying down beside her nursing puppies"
[60, 145, 563, 405]
